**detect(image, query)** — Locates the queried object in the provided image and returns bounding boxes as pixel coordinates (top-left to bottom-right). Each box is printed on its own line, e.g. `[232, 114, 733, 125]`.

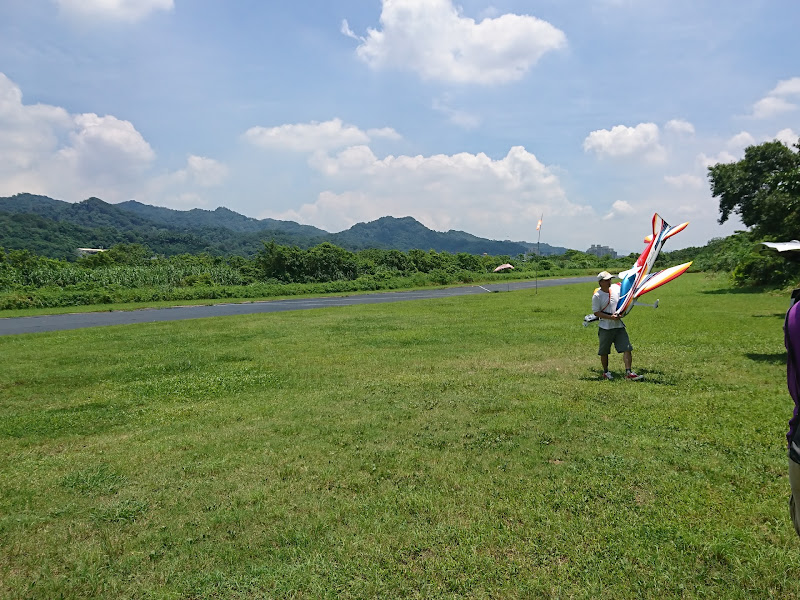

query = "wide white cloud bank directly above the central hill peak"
[262, 146, 592, 239]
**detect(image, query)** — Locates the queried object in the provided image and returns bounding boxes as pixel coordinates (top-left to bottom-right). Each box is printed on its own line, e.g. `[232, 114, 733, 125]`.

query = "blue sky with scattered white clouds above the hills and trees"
[0, 0, 800, 253]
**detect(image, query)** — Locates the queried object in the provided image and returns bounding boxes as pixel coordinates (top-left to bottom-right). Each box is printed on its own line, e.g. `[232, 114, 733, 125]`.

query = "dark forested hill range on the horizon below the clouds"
[0, 194, 566, 258]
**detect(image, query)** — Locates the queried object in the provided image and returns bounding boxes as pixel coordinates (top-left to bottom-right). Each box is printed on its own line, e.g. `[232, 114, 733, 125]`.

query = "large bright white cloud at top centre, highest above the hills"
[342, 0, 566, 85]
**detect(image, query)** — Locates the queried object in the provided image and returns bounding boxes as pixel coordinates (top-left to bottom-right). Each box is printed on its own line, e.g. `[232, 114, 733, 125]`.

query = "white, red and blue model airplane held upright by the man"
[583, 213, 692, 327]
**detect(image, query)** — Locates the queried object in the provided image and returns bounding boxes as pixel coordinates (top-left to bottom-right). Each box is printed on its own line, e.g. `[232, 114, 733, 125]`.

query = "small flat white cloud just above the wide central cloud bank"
[244, 118, 400, 152]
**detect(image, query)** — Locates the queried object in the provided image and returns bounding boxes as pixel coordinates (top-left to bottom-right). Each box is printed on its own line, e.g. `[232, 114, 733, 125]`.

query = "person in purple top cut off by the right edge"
[783, 290, 800, 535]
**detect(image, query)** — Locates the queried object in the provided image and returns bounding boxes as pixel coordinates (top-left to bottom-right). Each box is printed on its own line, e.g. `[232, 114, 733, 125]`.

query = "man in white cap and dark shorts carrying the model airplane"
[592, 271, 644, 381]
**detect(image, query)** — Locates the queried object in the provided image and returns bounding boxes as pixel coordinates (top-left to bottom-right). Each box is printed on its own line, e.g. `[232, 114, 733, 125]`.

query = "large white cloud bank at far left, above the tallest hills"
[0, 73, 238, 208]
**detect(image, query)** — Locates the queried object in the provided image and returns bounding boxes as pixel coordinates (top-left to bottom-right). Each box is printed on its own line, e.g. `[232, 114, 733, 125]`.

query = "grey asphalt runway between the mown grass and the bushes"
[0, 276, 596, 335]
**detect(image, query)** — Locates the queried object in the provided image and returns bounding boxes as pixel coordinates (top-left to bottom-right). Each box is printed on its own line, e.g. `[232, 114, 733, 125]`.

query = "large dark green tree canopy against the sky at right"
[708, 141, 800, 239]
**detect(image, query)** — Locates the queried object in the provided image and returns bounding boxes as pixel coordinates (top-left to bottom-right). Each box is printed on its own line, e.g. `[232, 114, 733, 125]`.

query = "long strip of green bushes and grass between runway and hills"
[0, 241, 688, 310]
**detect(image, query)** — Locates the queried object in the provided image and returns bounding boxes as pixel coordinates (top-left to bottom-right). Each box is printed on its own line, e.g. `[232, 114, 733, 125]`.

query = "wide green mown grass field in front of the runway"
[0, 274, 800, 599]
